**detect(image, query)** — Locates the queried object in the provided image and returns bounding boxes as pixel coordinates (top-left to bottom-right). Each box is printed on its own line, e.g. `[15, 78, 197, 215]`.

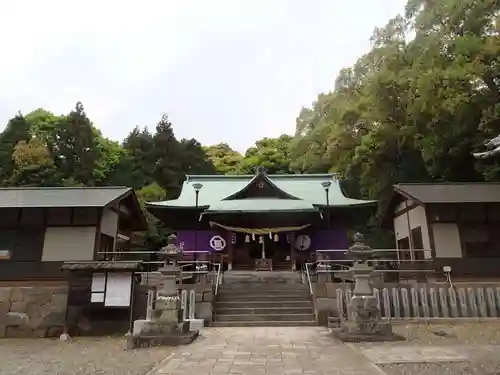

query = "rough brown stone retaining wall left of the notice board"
[0, 286, 68, 337]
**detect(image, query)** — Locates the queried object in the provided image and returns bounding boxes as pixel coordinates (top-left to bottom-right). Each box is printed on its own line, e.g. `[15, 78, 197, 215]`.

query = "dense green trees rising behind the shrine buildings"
[0, 0, 500, 250]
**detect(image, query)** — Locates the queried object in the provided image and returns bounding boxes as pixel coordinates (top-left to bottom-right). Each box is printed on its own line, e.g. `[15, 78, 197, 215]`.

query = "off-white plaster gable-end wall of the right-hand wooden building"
[394, 202, 432, 259]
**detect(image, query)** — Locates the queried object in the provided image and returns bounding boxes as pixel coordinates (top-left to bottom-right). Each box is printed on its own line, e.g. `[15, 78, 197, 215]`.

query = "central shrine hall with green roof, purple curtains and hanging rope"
[146, 170, 373, 270]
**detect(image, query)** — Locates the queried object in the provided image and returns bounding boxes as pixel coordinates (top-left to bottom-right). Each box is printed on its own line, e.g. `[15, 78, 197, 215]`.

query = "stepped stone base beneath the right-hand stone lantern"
[334, 321, 405, 342]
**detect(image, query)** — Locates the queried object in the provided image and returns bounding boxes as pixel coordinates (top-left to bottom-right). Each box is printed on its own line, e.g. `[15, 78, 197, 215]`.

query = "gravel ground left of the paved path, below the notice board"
[0, 337, 174, 375]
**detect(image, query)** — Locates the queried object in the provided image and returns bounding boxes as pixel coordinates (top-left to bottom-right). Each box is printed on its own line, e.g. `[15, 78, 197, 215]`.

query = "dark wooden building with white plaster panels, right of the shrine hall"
[384, 183, 500, 279]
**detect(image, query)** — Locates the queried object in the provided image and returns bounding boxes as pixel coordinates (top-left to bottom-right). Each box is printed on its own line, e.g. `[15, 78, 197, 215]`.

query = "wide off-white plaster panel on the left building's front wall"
[42, 227, 96, 262]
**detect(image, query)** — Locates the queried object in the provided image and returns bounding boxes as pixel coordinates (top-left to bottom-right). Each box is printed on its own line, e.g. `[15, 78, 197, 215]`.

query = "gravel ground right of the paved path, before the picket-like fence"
[355, 322, 500, 375]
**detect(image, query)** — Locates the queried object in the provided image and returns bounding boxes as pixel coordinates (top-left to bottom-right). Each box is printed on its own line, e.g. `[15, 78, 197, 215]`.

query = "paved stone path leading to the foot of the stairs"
[154, 327, 385, 375]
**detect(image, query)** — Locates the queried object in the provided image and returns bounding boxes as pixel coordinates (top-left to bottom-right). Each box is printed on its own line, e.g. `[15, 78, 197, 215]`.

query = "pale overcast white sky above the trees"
[0, 0, 405, 151]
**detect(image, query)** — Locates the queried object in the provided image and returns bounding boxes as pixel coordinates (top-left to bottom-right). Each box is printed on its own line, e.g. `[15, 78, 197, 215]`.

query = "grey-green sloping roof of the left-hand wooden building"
[0, 186, 133, 208]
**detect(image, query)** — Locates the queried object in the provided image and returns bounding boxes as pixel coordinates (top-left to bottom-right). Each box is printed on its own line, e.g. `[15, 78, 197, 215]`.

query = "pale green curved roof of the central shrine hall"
[148, 174, 373, 212]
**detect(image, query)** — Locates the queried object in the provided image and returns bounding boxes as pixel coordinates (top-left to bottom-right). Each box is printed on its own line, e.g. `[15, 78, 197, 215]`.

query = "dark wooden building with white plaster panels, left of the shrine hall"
[0, 187, 147, 281]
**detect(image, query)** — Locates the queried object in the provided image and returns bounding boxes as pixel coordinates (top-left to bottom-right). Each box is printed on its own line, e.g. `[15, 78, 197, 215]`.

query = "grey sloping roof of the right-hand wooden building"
[394, 182, 500, 204]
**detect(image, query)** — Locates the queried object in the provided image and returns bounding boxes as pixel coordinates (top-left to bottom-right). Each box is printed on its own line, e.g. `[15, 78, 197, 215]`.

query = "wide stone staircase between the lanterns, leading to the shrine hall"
[212, 271, 316, 327]
